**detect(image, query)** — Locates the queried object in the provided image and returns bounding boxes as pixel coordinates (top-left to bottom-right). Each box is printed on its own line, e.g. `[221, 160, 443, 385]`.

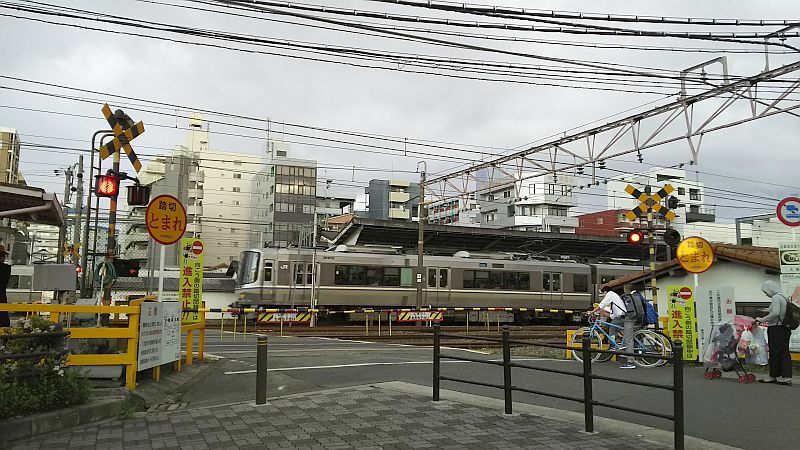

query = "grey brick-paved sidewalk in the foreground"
[8, 386, 666, 450]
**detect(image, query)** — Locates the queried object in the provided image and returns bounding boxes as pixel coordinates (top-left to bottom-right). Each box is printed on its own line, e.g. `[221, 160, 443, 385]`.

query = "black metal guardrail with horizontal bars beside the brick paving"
[433, 324, 685, 450]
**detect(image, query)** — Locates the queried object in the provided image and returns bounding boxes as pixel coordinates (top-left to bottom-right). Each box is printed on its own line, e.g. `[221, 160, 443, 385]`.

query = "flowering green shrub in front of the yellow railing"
[0, 315, 91, 419]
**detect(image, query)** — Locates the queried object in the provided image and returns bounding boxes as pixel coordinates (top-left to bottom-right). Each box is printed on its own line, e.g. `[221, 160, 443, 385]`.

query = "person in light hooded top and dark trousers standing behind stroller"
[753, 281, 792, 386]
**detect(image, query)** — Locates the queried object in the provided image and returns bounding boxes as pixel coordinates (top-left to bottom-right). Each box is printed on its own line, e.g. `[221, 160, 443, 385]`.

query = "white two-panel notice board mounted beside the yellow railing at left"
[137, 302, 181, 370]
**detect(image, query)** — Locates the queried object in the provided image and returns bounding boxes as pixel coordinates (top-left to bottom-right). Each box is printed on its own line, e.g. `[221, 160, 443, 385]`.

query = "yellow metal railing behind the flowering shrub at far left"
[0, 299, 144, 389]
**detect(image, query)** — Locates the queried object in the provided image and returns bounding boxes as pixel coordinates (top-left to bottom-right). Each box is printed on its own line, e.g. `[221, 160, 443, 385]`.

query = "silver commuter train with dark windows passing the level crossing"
[235, 248, 641, 320]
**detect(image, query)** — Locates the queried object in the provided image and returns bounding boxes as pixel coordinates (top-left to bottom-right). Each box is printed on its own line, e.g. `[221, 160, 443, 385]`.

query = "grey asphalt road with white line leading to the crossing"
[181, 330, 800, 449]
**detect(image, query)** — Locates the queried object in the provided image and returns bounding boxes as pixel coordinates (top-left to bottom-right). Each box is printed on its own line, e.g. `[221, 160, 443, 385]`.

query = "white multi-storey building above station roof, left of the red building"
[478, 174, 578, 233]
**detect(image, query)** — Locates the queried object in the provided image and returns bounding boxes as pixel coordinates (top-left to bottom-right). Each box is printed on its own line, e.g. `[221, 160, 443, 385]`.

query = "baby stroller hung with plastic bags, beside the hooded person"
[703, 316, 767, 383]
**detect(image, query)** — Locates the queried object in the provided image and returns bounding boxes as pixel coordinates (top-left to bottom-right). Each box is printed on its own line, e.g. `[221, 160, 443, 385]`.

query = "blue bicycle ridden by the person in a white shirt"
[571, 314, 671, 367]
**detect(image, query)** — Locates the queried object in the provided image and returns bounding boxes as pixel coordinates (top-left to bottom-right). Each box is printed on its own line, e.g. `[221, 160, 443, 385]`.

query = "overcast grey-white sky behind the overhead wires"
[0, 0, 800, 225]
